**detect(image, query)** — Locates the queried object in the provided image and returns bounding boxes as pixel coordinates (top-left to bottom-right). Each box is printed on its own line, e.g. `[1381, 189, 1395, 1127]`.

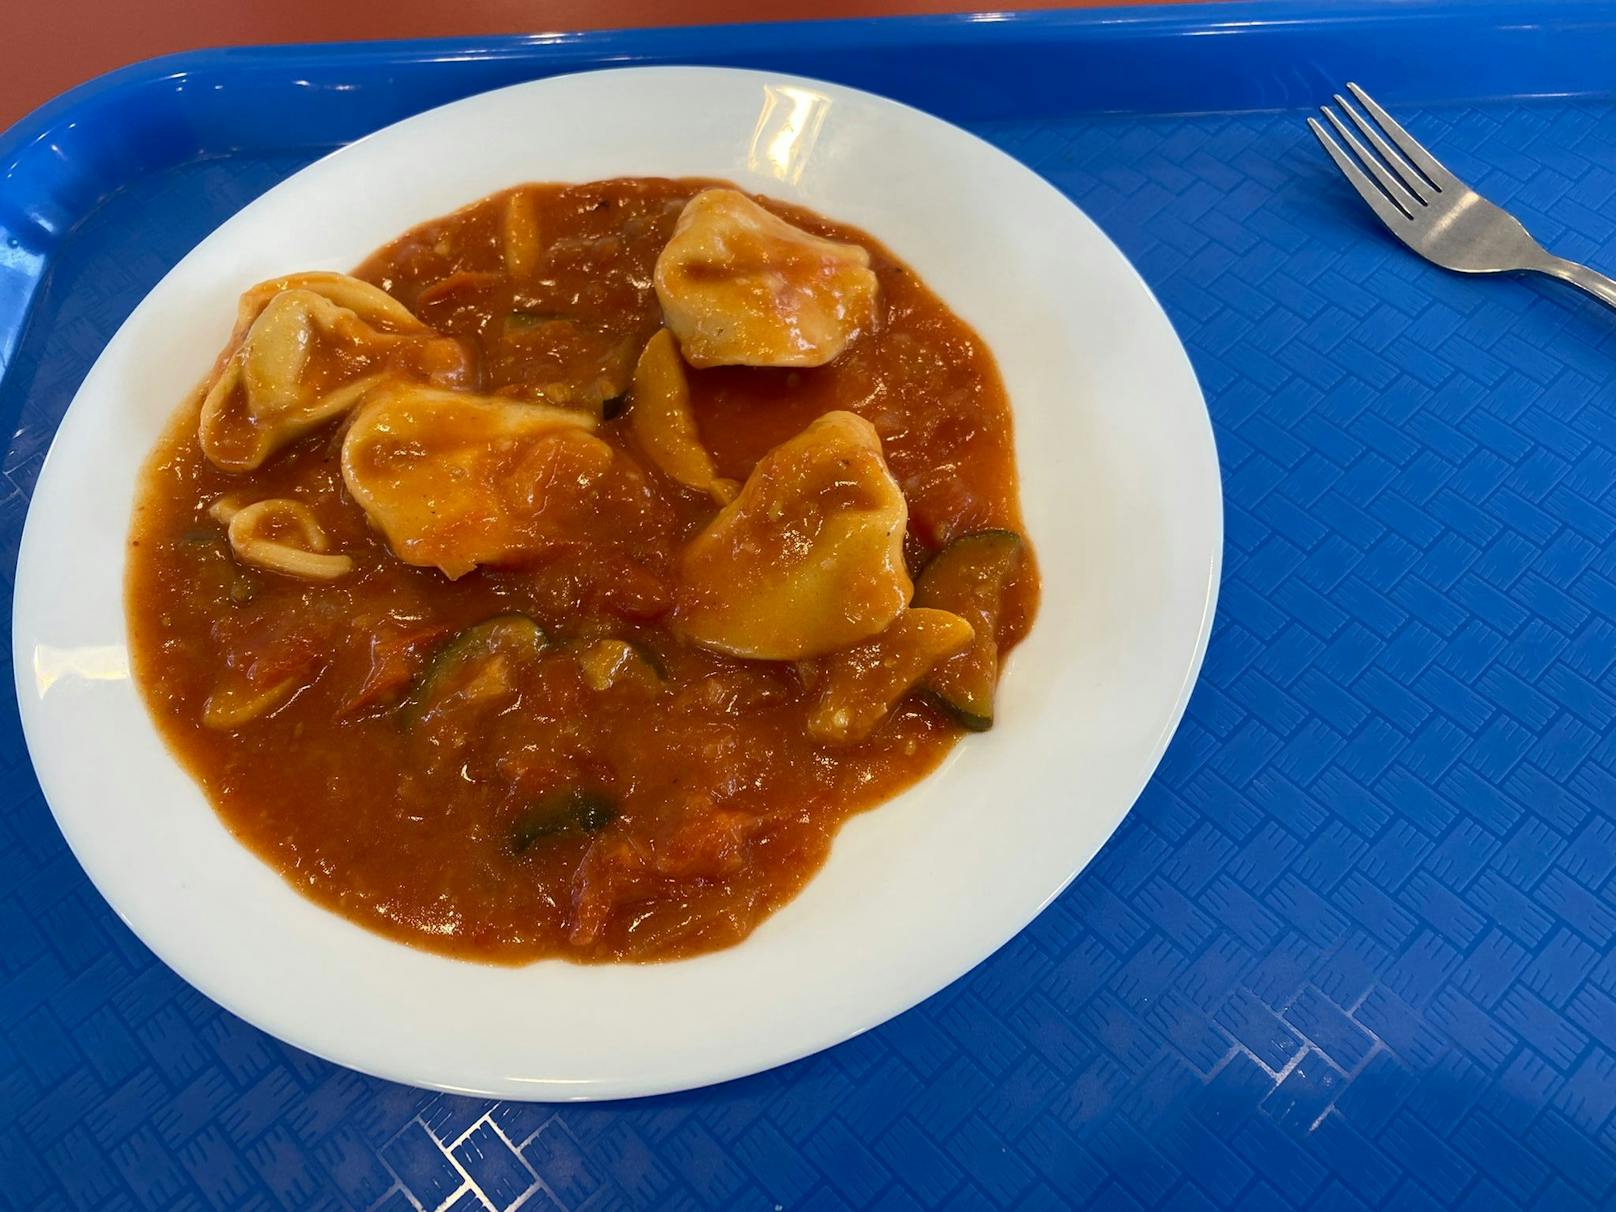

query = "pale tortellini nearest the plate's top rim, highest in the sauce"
[656, 189, 876, 367]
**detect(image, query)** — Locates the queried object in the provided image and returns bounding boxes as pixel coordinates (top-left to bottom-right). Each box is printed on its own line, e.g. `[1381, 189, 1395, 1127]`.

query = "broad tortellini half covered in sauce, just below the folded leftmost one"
[343, 383, 610, 579]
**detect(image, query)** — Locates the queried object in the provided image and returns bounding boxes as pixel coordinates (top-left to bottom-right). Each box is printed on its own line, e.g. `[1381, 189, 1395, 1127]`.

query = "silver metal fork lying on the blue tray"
[1307, 82, 1616, 307]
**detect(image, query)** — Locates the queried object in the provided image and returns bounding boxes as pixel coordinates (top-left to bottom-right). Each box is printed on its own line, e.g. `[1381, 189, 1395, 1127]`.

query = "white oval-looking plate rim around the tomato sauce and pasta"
[13, 68, 1222, 1099]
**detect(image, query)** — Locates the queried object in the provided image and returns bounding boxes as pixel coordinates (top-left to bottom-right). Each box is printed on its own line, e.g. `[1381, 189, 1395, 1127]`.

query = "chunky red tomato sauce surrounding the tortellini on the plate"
[128, 179, 1037, 962]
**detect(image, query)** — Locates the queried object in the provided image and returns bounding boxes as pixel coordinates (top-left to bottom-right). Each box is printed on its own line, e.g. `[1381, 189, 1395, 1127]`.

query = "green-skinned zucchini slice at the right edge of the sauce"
[915, 530, 1025, 732]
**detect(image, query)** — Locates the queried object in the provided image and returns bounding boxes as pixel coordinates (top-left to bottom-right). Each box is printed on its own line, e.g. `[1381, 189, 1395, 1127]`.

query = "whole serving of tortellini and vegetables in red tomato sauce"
[128, 179, 1037, 963]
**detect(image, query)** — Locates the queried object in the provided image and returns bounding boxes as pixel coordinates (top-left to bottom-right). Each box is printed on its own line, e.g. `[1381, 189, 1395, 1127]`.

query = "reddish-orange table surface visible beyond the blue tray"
[0, 0, 1176, 129]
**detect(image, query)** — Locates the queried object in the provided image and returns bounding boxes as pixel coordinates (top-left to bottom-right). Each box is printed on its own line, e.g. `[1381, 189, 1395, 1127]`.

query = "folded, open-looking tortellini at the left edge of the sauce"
[197, 273, 467, 472]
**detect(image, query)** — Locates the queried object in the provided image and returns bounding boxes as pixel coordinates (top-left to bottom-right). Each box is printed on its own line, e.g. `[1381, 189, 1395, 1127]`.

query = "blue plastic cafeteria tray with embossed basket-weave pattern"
[0, 0, 1616, 1212]
